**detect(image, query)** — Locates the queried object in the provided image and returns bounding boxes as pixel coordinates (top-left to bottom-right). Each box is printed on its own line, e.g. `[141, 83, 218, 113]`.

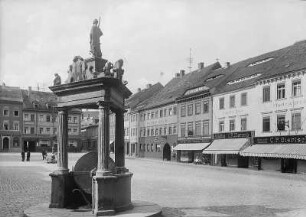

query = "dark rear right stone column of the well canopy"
[115, 109, 127, 173]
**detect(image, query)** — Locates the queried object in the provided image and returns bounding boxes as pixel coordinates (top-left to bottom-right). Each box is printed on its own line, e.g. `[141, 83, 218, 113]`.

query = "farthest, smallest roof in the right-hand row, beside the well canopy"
[125, 82, 163, 110]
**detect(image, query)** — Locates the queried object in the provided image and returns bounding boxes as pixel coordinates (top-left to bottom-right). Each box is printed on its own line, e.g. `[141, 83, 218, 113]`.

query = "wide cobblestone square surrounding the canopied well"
[0, 153, 306, 217]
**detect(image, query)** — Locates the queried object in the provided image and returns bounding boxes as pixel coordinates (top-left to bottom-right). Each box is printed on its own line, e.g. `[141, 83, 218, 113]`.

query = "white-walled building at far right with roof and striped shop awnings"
[209, 41, 306, 172]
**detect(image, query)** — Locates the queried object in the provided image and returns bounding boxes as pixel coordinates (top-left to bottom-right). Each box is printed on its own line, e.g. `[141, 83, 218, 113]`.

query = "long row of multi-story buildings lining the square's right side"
[112, 41, 306, 173]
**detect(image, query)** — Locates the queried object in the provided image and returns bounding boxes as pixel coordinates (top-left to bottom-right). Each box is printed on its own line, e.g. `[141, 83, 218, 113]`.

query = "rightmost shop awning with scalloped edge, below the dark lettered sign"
[240, 144, 306, 160]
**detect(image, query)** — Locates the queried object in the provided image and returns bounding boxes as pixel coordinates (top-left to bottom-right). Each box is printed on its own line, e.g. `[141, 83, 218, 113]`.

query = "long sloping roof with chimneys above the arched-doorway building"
[140, 62, 221, 109]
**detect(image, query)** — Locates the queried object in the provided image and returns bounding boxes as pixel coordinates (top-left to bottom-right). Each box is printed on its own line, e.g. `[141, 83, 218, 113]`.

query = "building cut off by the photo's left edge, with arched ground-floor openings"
[0, 85, 22, 152]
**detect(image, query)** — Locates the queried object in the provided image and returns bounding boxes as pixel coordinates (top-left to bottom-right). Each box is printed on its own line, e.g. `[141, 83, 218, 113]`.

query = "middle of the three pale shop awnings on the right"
[203, 138, 249, 154]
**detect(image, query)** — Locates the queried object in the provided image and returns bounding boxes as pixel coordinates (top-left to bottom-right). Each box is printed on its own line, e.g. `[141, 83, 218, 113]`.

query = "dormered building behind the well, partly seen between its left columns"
[22, 88, 81, 151]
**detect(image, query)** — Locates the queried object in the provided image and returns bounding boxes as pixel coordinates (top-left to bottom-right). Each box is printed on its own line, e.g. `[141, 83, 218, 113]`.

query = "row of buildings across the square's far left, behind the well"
[0, 85, 81, 152]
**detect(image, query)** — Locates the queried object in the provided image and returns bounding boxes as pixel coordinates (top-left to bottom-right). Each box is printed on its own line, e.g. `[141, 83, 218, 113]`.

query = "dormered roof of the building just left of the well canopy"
[22, 90, 57, 110]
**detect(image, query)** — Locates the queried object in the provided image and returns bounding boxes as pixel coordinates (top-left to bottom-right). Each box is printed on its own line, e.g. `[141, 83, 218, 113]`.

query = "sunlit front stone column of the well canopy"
[96, 102, 109, 176]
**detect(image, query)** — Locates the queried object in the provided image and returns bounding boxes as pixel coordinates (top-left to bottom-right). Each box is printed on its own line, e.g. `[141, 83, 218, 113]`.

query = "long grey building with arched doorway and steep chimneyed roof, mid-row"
[138, 63, 220, 160]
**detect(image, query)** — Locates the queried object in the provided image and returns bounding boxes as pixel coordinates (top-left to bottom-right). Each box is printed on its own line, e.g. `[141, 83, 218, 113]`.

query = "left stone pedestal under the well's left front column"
[49, 170, 72, 208]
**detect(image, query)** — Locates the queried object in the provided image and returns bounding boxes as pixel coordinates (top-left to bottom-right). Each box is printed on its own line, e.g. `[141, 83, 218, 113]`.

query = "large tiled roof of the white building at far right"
[216, 40, 306, 93]
